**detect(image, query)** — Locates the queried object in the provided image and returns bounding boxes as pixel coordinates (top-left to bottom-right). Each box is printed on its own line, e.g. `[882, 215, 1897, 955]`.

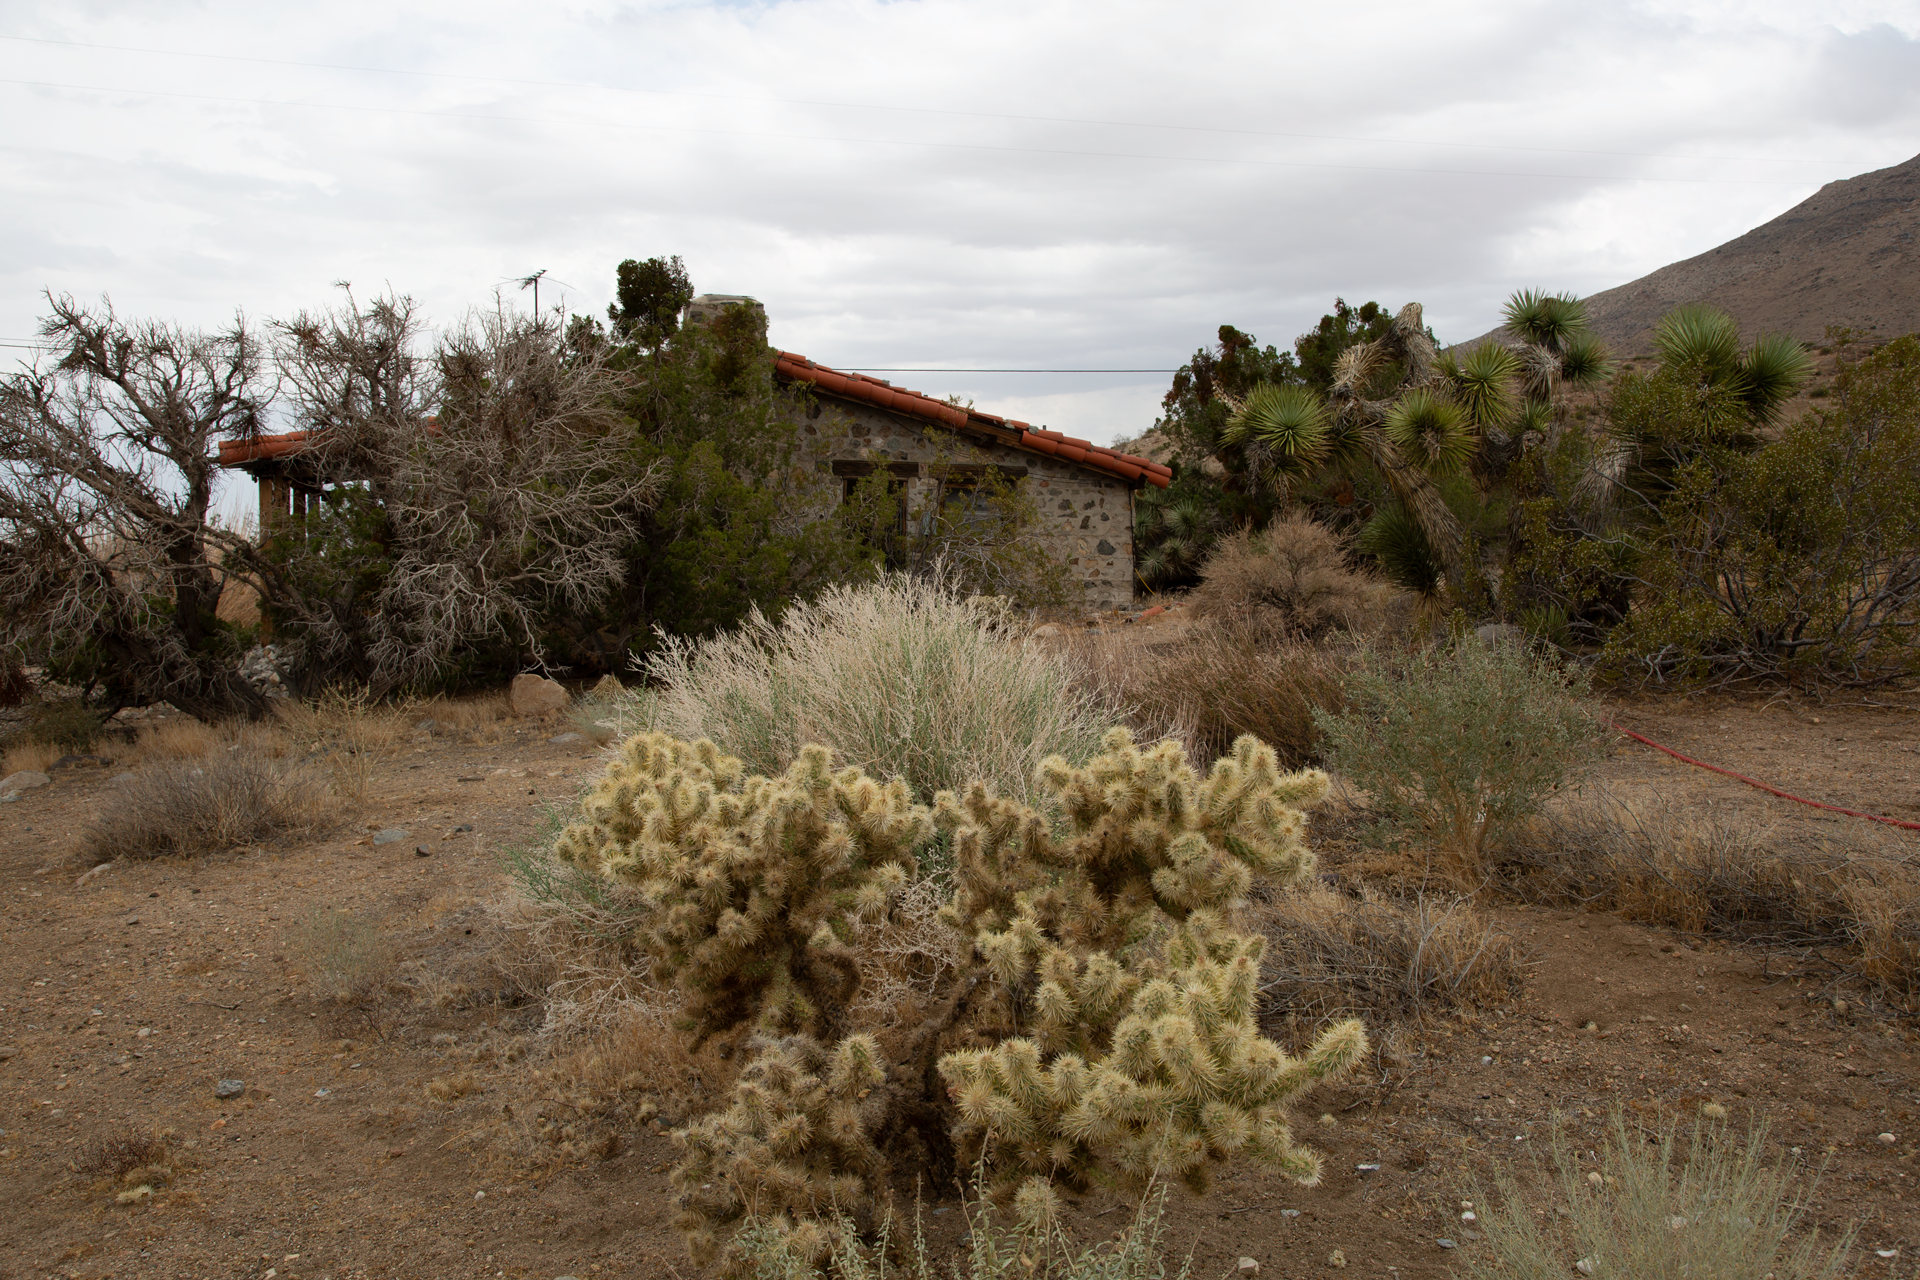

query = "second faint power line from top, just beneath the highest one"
[0, 79, 1807, 186]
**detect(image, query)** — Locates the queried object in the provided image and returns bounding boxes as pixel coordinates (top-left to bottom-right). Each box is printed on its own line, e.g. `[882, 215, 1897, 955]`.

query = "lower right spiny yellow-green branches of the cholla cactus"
[941, 913, 1367, 1197]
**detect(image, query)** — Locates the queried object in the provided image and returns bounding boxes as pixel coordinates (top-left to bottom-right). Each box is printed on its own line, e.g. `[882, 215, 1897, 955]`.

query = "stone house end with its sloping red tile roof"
[774, 351, 1173, 608]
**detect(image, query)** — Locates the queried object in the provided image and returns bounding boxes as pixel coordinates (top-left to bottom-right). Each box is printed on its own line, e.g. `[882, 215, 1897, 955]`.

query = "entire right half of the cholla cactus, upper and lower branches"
[939, 729, 1367, 1197]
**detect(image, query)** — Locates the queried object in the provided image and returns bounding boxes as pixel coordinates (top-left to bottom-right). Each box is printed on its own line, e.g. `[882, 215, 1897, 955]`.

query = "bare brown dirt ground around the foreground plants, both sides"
[0, 700, 1920, 1280]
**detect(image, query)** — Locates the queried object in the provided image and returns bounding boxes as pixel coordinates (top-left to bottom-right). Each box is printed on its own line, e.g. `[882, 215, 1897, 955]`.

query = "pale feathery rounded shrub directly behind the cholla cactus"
[647, 576, 1114, 802]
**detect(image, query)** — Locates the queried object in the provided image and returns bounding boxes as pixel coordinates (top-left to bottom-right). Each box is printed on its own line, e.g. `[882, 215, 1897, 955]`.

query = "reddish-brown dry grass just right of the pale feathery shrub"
[1075, 620, 1352, 770]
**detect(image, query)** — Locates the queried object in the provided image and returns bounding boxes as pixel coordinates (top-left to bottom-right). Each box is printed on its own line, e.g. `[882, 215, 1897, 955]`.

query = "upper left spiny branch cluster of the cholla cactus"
[555, 733, 933, 1038]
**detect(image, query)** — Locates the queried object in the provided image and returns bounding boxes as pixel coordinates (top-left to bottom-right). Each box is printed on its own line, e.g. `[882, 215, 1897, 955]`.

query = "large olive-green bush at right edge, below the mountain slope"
[1607, 336, 1920, 687]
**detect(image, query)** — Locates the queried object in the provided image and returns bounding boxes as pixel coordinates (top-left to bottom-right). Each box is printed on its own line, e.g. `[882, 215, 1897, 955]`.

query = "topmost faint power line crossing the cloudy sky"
[0, 35, 1824, 163]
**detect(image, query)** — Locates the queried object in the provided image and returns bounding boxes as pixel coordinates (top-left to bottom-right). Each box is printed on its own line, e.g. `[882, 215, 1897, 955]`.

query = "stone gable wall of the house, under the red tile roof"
[801, 395, 1133, 608]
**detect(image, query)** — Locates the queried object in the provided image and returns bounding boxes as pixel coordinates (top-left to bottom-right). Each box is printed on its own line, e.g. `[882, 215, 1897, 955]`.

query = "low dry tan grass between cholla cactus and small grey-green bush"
[1252, 885, 1530, 1023]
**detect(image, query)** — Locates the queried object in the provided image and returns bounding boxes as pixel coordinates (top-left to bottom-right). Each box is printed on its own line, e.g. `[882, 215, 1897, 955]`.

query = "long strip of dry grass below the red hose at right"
[1505, 789, 1920, 1007]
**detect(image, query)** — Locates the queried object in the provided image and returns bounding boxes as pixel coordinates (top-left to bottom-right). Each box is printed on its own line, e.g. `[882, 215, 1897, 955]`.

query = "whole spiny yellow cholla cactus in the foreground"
[555, 729, 1367, 1276]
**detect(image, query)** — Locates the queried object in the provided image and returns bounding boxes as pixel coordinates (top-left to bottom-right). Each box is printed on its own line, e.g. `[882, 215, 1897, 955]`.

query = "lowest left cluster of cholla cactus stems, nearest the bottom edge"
[670, 1036, 887, 1276]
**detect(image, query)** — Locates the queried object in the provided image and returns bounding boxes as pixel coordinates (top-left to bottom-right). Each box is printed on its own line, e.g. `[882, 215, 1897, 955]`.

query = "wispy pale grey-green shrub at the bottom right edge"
[1467, 1109, 1855, 1280]
